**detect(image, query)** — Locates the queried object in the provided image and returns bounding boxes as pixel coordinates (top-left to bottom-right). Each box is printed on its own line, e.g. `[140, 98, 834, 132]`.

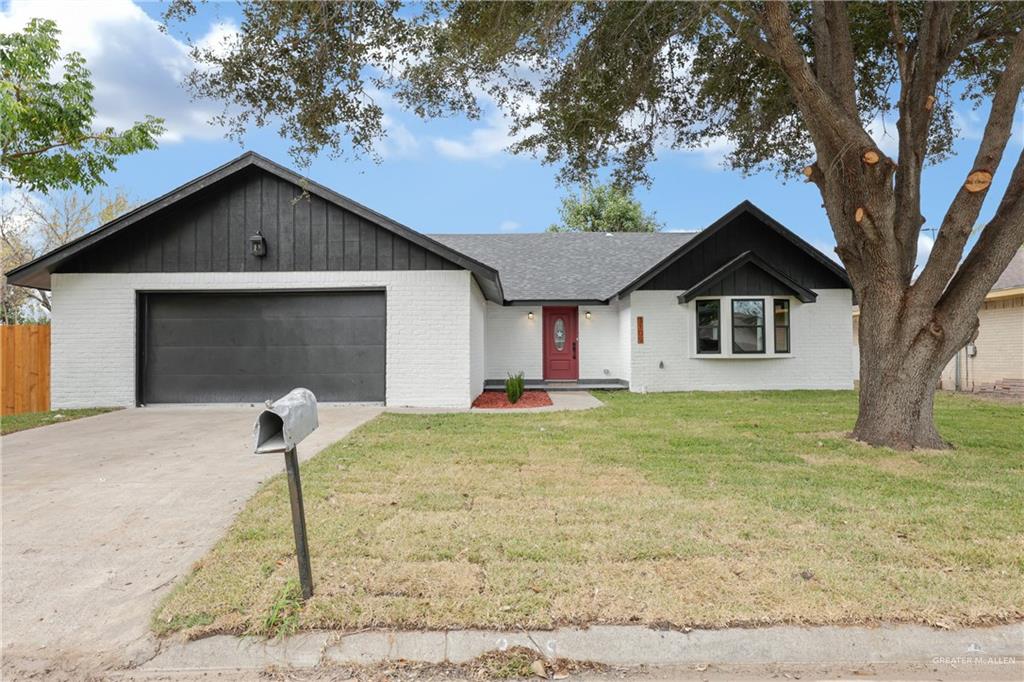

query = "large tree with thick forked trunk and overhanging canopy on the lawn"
[169, 0, 1024, 449]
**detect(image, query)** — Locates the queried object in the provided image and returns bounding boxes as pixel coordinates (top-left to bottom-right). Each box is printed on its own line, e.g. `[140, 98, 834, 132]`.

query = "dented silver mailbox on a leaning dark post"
[253, 388, 319, 599]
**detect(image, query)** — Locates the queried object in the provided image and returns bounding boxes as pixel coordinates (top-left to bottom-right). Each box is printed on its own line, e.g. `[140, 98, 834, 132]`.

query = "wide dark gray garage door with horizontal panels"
[138, 291, 385, 403]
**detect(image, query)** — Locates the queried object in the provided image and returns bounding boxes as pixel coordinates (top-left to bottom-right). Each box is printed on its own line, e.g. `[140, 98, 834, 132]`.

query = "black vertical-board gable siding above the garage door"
[59, 168, 462, 272]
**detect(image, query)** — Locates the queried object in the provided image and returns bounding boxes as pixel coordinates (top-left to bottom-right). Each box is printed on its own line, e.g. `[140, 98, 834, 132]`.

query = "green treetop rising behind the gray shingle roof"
[548, 184, 662, 232]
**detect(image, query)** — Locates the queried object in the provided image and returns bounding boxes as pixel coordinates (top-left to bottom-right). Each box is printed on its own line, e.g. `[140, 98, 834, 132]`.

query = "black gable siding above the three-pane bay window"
[639, 214, 850, 296]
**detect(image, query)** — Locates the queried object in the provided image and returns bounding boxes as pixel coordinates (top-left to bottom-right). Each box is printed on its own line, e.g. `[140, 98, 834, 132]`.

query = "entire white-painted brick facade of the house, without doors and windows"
[51, 270, 854, 408]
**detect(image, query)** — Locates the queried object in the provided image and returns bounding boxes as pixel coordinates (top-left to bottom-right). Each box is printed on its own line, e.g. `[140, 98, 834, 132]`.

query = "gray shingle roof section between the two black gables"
[430, 232, 697, 301]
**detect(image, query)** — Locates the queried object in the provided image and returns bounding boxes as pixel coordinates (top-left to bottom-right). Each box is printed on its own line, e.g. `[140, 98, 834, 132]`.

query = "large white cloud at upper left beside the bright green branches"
[0, 0, 228, 142]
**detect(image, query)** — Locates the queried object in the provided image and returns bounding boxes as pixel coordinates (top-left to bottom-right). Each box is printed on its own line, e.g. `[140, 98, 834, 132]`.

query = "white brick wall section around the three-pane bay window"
[630, 289, 854, 392]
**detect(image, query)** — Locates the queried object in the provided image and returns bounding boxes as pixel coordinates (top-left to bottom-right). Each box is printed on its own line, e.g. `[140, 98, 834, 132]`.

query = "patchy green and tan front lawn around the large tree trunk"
[154, 391, 1024, 636]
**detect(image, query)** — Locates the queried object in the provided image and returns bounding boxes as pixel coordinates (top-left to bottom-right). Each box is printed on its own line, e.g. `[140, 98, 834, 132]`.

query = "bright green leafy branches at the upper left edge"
[0, 19, 164, 191]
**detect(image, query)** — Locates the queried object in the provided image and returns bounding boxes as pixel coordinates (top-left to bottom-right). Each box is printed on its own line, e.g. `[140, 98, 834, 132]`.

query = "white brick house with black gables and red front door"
[8, 154, 853, 408]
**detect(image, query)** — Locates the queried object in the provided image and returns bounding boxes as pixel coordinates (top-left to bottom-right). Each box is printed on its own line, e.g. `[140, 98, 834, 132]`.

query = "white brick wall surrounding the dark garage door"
[51, 270, 482, 408]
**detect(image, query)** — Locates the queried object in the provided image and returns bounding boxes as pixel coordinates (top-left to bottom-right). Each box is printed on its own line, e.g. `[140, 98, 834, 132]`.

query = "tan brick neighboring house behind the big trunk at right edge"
[942, 250, 1024, 393]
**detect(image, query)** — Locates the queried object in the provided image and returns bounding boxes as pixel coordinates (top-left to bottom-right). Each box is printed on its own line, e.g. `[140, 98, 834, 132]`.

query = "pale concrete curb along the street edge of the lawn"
[140, 624, 1024, 672]
